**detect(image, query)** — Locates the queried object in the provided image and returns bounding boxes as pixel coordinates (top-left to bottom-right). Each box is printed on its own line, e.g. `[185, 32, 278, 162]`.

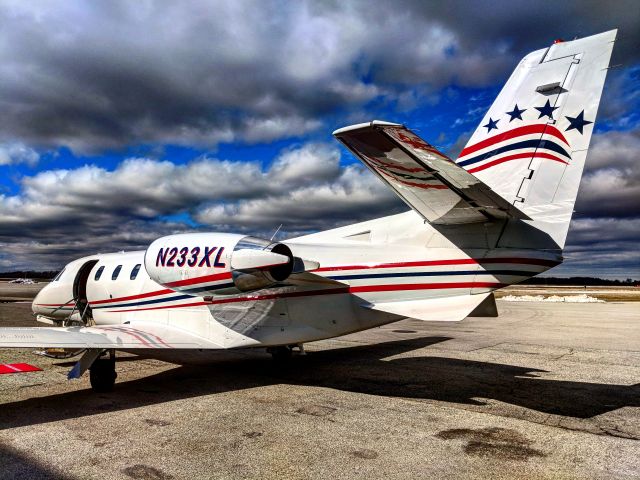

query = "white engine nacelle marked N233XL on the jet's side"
[144, 233, 295, 296]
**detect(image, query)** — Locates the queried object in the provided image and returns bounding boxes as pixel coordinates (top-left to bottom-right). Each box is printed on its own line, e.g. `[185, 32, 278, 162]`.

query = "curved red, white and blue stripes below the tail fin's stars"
[456, 123, 571, 173]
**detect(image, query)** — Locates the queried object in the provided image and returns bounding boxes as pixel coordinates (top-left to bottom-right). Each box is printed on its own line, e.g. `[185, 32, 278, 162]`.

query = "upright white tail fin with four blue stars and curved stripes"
[456, 30, 617, 248]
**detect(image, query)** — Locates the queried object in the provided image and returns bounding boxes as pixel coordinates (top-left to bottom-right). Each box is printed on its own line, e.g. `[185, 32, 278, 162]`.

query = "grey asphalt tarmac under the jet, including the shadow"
[0, 292, 640, 479]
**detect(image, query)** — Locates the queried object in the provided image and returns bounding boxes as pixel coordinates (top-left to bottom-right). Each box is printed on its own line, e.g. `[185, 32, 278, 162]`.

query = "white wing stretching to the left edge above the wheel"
[0, 322, 223, 350]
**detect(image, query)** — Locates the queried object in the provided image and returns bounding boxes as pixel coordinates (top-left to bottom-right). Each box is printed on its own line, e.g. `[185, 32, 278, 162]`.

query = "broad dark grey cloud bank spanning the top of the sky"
[0, 1, 640, 152]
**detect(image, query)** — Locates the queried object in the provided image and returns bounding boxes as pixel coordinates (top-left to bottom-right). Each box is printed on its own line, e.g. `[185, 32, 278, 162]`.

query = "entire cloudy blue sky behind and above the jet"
[0, 0, 640, 278]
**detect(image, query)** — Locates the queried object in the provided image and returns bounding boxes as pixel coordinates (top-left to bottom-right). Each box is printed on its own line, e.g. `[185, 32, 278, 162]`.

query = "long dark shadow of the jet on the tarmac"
[0, 337, 640, 429]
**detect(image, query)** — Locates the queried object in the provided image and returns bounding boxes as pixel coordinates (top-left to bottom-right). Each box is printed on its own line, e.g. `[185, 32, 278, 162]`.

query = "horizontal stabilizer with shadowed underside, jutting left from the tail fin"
[333, 120, 528, 224]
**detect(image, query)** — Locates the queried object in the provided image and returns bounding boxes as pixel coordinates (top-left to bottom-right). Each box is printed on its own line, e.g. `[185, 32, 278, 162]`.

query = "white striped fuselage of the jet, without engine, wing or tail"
[33, 211, 561, 348]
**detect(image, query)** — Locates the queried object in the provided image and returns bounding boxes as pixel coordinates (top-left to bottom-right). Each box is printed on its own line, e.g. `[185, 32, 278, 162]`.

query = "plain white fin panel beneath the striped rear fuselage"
[365, 293, 493, 322]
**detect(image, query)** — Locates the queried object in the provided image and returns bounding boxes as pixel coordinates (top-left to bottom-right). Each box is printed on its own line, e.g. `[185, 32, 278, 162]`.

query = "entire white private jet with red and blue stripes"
[0, 30, 616, 391]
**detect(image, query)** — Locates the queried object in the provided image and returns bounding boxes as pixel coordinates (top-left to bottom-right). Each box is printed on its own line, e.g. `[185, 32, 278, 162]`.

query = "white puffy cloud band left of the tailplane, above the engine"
[0, 143, 404, 268]
